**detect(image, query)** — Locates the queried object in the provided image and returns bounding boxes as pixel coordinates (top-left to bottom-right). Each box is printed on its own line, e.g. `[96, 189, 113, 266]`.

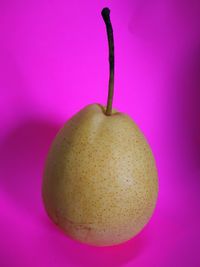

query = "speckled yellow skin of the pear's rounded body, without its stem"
[42, 104, 158, 246]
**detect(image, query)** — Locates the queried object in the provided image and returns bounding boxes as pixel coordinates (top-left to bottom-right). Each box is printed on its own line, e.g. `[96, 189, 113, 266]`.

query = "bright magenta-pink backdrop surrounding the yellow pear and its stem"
[0, 0, 200, 267]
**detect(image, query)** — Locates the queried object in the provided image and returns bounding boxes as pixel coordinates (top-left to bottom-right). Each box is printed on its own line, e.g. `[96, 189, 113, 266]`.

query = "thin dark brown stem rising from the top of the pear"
[101, 7, 114, 116]
